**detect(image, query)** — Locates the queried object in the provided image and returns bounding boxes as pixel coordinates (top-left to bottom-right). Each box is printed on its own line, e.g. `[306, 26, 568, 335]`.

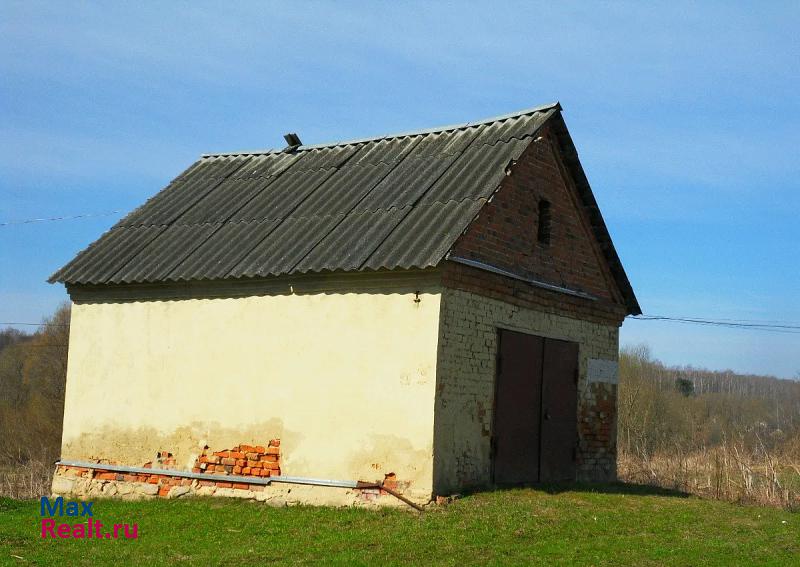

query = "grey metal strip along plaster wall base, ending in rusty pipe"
[56, 460, 423, 512]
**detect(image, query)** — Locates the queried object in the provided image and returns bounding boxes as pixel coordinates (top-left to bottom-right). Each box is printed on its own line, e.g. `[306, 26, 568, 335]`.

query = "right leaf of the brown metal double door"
[539, 339, 578, 482]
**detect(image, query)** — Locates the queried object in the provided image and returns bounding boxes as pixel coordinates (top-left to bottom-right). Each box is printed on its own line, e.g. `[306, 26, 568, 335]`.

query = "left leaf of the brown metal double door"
[492, 330, 544, 484]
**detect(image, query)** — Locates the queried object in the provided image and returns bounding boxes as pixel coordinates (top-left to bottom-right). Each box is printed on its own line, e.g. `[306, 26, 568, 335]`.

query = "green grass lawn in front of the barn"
[0, 486, 800, 566]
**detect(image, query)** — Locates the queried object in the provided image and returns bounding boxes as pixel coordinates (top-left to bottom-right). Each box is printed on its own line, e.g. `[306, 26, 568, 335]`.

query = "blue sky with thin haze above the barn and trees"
[0, 2, 800, 377]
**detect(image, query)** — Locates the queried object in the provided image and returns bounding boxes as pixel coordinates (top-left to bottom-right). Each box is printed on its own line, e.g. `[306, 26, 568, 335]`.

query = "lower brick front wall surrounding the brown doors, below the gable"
[434, 288, 619, 495]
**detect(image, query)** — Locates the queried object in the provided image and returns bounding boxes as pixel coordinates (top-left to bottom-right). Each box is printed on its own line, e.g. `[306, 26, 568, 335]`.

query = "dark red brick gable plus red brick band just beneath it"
[443, 129, 626, 325]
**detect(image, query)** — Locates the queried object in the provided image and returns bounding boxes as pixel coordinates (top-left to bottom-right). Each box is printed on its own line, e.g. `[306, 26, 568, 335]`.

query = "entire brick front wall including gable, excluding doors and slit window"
[434, 121, 627, 494]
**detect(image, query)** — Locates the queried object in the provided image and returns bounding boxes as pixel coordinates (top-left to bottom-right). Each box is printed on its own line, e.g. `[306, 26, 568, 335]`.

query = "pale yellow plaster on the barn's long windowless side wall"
[62, 289, 441, 498]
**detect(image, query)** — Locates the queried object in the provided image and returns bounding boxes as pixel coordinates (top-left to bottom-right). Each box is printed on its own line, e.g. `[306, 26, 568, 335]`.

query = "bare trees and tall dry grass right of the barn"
[617, 346, 800, 508]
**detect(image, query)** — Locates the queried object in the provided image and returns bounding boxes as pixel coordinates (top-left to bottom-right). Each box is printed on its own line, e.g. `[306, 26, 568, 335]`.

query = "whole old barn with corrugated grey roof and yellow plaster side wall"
[51, 104, 640, 504]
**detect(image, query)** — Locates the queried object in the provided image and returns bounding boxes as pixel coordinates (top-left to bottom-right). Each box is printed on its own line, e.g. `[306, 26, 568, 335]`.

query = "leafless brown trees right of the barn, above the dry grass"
[618, 346, 800, 456]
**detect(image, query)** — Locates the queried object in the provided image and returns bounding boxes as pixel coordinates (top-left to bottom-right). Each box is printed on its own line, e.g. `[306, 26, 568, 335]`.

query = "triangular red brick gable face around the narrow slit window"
[451, 127, 624, 304]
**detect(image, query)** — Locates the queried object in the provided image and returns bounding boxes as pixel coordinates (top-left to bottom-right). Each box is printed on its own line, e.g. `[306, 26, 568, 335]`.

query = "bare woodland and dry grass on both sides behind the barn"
[0, 304, 800, 507]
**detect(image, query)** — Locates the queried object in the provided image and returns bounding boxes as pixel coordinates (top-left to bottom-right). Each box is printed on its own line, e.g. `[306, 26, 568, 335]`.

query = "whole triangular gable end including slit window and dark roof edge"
[448, 108, 641, 314]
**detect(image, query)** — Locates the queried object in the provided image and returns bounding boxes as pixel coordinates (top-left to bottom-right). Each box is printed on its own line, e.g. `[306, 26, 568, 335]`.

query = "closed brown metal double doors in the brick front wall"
[492, 329, 578, 485]
